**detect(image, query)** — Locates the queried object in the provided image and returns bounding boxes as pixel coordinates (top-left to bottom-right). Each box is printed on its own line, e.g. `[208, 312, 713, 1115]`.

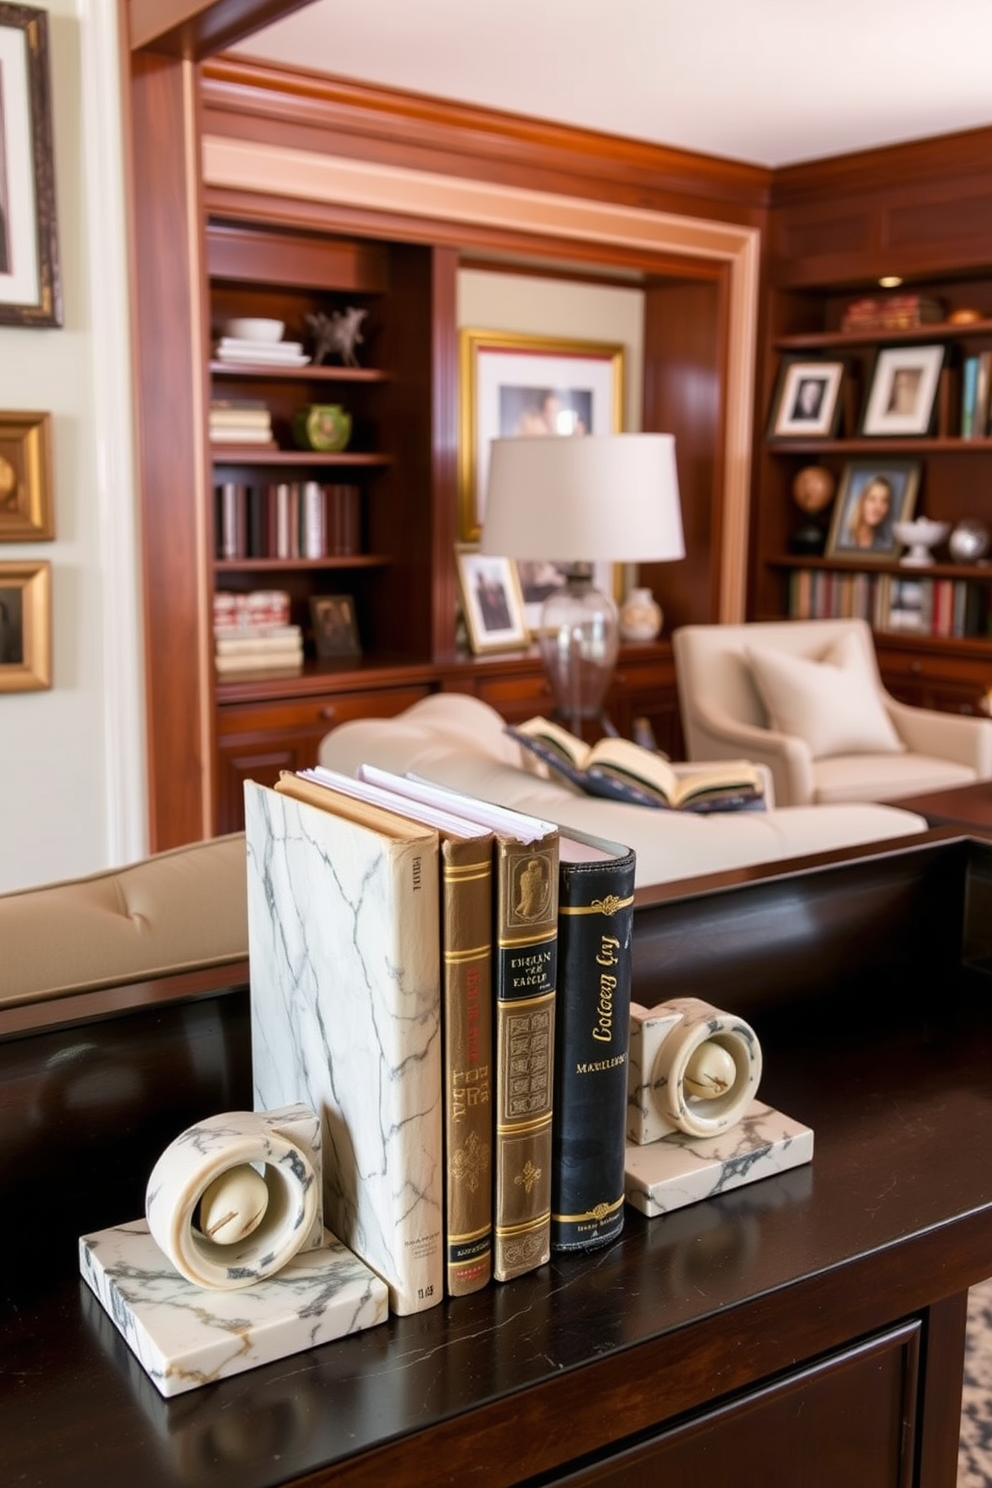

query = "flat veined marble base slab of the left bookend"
[79, 1220, 388, 1396]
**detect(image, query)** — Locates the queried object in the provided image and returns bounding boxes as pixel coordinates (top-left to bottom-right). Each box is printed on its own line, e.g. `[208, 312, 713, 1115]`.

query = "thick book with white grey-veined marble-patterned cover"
[245, 783, 445, 1312]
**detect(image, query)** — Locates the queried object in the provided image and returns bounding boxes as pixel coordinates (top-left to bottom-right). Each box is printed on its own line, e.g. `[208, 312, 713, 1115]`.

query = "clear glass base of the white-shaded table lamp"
[540, 565, 620, 734]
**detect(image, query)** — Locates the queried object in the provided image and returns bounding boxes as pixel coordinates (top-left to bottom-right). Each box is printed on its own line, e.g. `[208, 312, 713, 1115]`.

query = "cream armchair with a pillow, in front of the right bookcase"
[672, 619, 992, 806]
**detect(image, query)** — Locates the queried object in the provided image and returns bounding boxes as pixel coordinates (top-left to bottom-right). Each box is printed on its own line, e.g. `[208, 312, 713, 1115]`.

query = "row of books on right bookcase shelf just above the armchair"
[788, 568, 988, 637]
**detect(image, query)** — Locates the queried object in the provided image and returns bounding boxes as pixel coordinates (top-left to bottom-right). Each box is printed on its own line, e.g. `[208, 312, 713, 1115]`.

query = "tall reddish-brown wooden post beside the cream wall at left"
[129, 54, 211, 851]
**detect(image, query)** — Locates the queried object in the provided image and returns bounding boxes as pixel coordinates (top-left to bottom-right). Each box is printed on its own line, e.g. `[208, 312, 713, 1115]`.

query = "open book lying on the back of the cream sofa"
[507, 717, 764, 811]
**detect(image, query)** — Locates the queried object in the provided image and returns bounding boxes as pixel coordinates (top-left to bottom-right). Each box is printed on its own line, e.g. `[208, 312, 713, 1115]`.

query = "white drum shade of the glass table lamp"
[480, 434, 686, 562]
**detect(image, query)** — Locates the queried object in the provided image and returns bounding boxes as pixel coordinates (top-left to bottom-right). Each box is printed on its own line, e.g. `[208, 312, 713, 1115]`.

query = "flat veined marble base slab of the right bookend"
[625, 1101, 814, 1219]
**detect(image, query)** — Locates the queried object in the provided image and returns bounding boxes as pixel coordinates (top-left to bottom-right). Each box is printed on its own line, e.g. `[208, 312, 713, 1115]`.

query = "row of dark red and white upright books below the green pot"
[214, 481, 361, 561]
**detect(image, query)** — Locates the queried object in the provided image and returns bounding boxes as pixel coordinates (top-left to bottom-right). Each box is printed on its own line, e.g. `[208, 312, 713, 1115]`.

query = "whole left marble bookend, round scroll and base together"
[79, 1106, 388, 1396]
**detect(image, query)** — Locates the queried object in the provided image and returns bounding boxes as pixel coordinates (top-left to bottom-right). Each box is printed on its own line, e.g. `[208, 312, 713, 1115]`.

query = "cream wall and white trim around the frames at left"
[0, 0, 147, 890]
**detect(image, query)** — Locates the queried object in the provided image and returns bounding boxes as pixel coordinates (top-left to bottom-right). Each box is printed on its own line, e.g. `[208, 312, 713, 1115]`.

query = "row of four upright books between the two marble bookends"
[245, 766, 635, 1314]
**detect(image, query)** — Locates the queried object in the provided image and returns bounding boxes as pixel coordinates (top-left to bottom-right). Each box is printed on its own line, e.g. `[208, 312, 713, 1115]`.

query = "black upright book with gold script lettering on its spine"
[552, 827, 635, 1251]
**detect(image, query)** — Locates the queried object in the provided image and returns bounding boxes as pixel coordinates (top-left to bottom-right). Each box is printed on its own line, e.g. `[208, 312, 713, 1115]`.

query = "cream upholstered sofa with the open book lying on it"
[318, 693, 927, 885]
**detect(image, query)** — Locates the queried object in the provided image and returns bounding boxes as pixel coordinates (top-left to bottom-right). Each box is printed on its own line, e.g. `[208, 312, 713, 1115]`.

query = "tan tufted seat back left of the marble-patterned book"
[0, 833, 248, 1006]
